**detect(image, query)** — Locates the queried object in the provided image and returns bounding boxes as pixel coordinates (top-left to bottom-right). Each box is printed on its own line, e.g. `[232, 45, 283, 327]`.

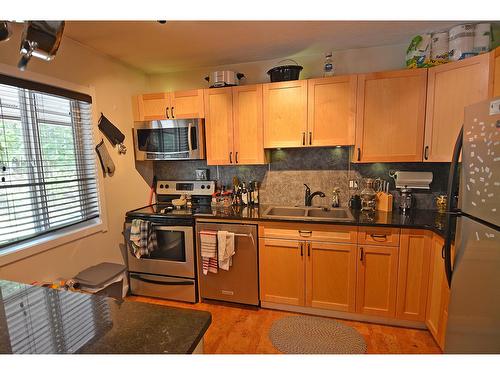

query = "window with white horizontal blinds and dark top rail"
[0, 75, 99, 252]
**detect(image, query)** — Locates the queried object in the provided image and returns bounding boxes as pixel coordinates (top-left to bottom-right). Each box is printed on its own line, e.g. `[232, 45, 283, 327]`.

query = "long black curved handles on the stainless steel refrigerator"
[443, 125, 464, 287]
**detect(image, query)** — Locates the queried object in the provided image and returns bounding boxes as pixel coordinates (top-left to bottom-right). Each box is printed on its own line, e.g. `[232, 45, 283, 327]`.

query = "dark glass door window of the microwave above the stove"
[137, 126, 198, 153]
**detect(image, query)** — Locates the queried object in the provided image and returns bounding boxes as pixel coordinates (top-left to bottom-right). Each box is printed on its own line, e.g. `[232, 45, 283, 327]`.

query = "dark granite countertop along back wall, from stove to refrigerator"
[195, 205, 454, 236]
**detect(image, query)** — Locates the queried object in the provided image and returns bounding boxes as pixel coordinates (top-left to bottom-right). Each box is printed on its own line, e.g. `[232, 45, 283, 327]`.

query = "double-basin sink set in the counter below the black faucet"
[262, 206, 354, 221]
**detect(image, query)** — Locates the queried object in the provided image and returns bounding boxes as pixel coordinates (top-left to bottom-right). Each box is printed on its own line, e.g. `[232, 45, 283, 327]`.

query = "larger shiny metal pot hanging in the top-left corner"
[17, 21, 64, 70]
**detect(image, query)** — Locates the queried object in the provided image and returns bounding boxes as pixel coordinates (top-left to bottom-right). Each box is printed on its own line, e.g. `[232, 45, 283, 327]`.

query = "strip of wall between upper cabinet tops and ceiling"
[149, 45, 407, 92]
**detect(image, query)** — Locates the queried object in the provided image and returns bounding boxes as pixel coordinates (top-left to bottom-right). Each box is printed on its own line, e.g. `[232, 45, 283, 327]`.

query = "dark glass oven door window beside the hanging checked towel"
[148, 230, 186, 262]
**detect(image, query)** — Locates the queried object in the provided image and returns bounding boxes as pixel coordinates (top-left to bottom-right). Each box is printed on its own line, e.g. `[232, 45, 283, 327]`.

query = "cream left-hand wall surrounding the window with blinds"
[0, 27, 152, 282]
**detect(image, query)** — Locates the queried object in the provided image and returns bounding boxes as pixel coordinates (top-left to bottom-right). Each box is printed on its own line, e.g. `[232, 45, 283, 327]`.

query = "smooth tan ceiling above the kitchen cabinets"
[65, 21, 458, 74]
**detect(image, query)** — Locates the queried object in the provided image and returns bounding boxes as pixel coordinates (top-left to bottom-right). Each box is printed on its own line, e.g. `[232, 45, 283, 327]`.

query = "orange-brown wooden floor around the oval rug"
[127, 296, 441, 354]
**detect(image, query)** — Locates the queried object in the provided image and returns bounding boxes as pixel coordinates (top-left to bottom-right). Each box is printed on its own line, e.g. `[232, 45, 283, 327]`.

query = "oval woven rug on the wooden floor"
[269, 316, 366, 354]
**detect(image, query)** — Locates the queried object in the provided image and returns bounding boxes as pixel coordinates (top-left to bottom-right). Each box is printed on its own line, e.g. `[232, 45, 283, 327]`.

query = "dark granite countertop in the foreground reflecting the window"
[0, 280, 212, 354]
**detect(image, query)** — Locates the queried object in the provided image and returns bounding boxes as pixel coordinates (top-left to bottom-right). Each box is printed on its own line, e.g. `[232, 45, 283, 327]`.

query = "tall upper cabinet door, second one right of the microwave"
[233, 85, 266, 164]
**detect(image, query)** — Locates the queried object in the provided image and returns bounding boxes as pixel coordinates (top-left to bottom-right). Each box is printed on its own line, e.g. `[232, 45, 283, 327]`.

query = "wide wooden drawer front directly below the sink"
[259, 223, 358, 243]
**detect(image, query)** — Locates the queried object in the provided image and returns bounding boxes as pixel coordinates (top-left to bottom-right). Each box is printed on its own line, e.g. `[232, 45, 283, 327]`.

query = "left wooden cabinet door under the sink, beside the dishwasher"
[259, 238, 305, 306]
